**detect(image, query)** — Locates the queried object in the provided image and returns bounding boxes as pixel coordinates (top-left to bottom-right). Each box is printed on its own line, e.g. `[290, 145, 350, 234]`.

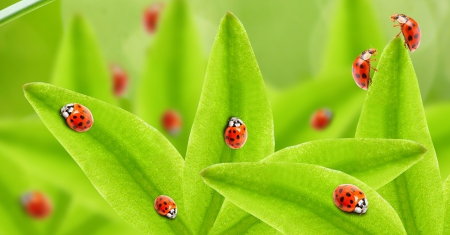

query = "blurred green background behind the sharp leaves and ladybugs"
[0, 0, 450, 234]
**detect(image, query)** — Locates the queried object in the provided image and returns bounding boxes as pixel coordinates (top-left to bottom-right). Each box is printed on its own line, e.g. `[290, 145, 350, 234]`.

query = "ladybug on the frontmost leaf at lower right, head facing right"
[333, 184, 369, 214]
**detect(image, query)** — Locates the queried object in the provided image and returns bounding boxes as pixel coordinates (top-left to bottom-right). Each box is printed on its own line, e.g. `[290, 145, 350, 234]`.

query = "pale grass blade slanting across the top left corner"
[0, 0, 53, 26]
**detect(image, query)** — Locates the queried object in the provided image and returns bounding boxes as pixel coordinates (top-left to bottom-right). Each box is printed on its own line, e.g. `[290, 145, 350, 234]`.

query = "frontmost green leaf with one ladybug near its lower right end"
[201, 163, 406, 234]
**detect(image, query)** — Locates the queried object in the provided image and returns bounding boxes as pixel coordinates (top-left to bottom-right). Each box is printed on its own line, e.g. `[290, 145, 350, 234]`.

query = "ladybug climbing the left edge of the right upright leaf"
[352, 48, 377, 90]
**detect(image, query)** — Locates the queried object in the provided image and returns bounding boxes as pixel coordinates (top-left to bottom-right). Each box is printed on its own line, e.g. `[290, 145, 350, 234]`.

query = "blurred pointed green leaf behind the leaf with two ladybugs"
[52, 15, 115, 103]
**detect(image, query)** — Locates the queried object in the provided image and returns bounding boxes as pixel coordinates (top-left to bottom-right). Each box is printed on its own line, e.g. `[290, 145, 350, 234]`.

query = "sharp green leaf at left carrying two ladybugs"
[24, 83, 189, 234]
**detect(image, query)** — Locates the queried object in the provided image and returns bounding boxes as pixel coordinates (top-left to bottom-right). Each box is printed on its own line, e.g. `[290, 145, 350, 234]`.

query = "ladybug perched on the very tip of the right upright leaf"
[391, 14, 422, 52]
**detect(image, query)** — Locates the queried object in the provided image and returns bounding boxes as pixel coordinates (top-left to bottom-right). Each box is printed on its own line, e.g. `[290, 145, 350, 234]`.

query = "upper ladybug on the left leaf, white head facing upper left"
[61, 103, 94, 132]
